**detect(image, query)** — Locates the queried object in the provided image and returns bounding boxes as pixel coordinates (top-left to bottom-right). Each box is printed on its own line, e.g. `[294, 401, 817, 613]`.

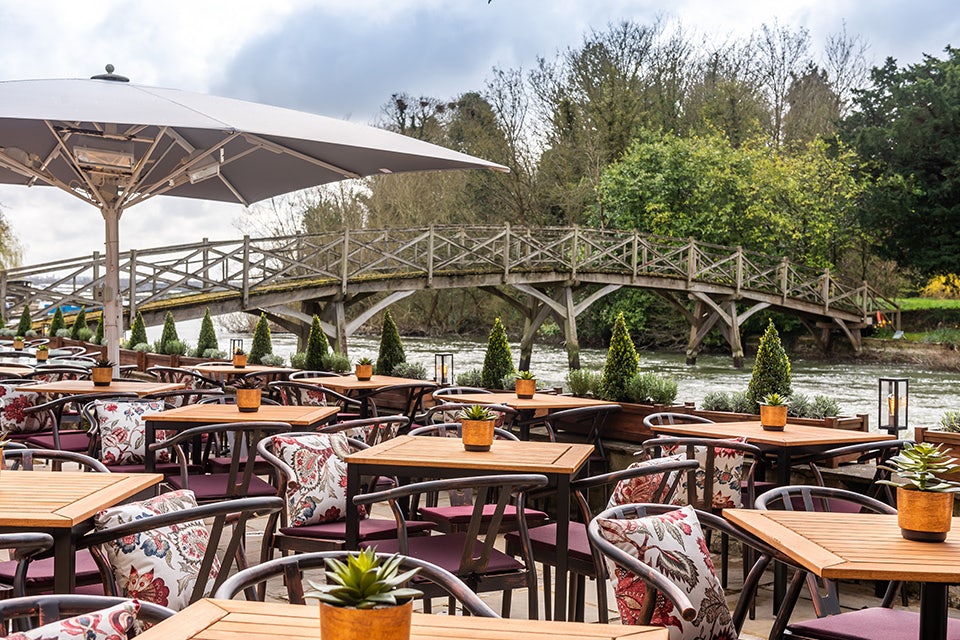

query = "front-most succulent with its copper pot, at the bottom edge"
[304, 549, 423, 640]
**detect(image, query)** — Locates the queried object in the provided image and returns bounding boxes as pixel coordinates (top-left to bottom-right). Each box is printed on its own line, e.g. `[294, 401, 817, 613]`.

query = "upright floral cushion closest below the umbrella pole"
[94, 400, 170, 467]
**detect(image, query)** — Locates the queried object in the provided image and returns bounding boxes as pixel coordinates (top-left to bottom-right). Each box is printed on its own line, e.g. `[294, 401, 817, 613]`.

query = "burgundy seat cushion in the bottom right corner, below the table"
[787, 607, 960, 640]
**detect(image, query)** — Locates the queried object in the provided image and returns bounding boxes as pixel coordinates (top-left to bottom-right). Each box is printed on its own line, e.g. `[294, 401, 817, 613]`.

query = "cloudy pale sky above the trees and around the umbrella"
[0, 0, 960, 264]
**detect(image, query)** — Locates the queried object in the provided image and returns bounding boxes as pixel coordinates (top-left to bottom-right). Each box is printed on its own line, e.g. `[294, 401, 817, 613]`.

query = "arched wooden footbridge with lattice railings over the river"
[0, 224, 899, 368]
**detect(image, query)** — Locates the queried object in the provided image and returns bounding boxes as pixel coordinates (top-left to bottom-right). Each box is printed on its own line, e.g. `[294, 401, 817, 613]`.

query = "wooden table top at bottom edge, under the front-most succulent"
[137, 598, 668, 640]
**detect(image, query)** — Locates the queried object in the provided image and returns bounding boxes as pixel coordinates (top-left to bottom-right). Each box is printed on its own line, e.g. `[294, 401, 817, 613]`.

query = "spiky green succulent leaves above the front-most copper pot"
[304, 548, 423, 609]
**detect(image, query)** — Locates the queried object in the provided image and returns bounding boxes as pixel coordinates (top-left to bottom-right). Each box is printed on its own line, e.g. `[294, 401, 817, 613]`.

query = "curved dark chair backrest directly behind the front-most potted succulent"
[213, 551, 500, 618]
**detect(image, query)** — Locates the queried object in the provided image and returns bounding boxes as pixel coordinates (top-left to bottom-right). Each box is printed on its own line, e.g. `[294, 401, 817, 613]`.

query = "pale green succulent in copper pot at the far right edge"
[878, 442, 960, 542]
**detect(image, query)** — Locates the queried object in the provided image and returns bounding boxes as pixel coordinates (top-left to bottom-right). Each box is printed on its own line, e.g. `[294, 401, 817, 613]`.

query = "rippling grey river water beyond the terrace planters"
[147, 321, 960, 434]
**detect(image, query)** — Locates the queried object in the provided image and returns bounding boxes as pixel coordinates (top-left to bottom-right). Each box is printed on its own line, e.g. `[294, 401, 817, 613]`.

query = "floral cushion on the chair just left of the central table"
[272, 432, 366, 527]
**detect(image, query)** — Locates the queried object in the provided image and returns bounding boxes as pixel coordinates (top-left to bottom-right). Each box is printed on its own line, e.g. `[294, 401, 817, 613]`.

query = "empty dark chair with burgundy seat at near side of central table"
[353, 474, 548, 620]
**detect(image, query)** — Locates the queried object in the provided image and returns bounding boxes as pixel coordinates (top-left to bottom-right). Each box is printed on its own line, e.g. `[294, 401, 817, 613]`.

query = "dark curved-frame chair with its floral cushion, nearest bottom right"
[587, 504, 780, 638]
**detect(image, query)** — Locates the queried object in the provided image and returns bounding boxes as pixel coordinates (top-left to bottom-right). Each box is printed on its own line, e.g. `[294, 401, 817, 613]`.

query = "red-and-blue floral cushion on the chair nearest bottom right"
[598, 506, 737, 640]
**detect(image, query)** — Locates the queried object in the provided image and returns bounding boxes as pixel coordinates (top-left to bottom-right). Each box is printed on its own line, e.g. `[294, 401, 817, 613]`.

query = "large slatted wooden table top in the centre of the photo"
[346, 436, 594, 475]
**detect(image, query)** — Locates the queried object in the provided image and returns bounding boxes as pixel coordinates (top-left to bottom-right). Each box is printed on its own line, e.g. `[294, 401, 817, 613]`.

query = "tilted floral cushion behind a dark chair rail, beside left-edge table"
[94, 490, 220, 611]
